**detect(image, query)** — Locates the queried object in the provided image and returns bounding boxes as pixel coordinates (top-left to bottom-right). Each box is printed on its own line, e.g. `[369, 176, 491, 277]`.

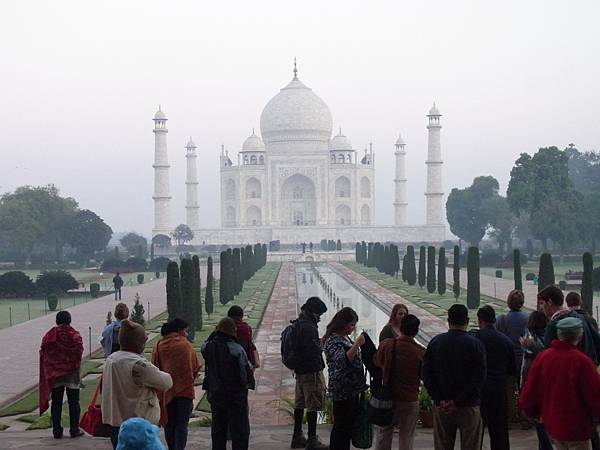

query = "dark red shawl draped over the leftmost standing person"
[40, 325, 83, 415]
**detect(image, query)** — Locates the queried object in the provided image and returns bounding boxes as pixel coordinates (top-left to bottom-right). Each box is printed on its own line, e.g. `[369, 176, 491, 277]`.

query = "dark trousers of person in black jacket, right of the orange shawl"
[210, 402, 250, 450]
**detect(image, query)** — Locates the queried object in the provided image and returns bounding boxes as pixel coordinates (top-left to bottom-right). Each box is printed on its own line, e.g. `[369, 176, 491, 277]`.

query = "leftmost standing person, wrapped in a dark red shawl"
[39, 311, 83, 439]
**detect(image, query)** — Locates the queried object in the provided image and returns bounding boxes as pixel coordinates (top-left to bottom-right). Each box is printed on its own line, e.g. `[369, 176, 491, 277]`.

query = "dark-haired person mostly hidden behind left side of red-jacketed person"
[521, 311, 554, 450]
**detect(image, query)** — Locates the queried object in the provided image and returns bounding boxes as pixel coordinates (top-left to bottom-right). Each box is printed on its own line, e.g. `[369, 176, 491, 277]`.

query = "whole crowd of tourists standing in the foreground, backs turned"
[39, 286, 600, 450]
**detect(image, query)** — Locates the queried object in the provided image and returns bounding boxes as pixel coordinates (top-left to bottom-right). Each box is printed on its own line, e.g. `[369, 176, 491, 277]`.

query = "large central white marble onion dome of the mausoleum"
[260, 78, 332, 143]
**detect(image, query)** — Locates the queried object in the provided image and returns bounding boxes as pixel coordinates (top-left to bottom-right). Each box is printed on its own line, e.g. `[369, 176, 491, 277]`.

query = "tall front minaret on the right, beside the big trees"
[425, 103, 444, 225]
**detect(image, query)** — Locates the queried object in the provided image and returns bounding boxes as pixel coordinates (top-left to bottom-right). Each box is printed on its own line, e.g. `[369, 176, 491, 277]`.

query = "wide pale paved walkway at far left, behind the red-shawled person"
[0, 278, 166, 407]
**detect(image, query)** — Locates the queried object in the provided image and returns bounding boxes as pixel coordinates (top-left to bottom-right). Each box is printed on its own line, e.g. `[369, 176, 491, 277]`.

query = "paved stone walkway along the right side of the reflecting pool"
[329, 262, 448, 342]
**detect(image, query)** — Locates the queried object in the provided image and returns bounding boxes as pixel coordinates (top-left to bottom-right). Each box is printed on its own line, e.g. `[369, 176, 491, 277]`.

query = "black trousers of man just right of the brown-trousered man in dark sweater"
[481, 384, 510, 450]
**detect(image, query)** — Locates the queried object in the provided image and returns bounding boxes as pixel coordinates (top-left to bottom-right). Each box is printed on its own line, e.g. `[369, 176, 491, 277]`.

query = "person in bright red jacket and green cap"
[519, 317, 600, 450]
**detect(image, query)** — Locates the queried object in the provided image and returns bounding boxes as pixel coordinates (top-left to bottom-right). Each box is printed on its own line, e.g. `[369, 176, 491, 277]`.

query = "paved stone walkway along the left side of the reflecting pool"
[248, 262, 298, 426]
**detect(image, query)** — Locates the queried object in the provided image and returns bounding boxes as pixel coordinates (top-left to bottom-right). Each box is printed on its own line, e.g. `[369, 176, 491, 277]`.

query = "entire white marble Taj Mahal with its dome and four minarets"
[152, 62, 446, 244]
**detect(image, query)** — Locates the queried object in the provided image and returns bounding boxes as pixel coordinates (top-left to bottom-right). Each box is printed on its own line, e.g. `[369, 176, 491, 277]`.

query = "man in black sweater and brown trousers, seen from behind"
[423, 304, 486, 450]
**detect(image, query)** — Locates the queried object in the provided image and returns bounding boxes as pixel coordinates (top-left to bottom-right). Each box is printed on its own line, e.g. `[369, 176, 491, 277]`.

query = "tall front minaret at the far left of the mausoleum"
[152, 106, 171, 236]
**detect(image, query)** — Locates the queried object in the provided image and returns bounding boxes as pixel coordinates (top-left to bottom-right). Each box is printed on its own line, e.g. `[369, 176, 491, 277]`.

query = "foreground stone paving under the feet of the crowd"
[0, 425, 537, 450]
